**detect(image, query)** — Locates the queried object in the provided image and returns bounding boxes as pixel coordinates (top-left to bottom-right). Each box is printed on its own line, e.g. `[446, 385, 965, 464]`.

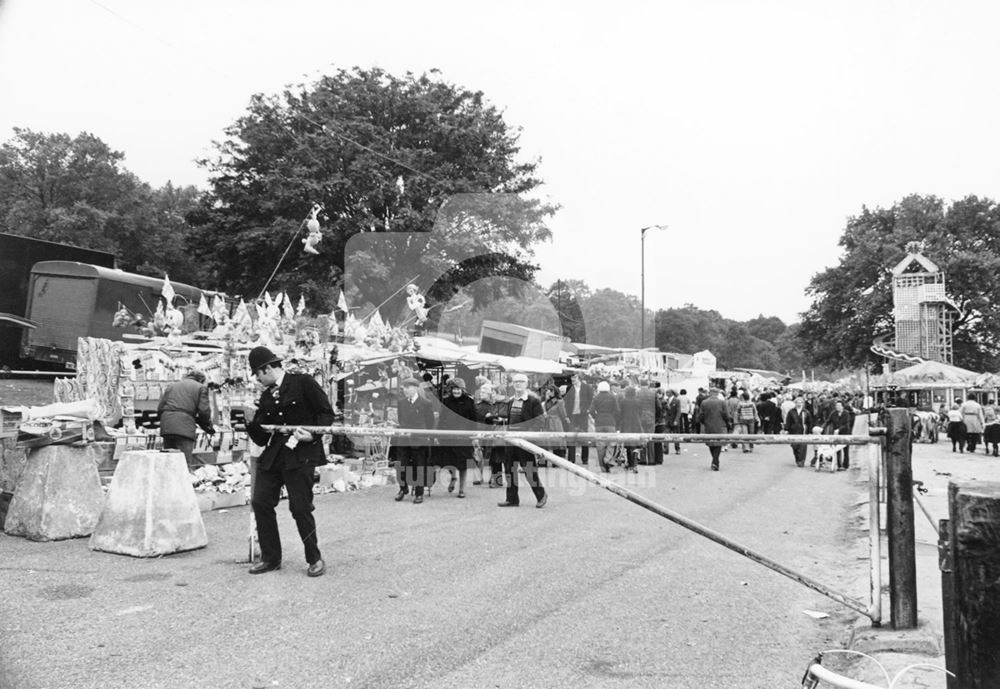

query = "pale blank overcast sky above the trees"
[0, 0, 1000, 322]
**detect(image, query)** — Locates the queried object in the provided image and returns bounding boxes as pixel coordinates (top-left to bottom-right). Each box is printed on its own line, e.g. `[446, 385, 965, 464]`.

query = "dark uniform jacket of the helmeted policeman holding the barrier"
[247, 373, 334, 470]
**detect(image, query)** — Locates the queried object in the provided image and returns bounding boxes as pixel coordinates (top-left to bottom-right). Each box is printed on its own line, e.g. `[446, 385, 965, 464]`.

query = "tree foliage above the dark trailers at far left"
[0, 128, 198, 282]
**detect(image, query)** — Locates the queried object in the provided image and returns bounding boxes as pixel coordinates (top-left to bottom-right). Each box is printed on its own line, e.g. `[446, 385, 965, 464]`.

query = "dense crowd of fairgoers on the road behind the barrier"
[382, 373, 862, 490]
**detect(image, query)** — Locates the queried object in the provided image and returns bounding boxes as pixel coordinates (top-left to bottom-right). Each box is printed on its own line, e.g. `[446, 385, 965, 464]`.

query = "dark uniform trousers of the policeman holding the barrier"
[250, 457, 321, 565]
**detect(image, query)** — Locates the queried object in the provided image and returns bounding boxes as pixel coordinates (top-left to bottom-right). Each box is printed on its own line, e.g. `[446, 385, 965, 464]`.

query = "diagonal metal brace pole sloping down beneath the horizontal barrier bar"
[504, 438, 870, 617]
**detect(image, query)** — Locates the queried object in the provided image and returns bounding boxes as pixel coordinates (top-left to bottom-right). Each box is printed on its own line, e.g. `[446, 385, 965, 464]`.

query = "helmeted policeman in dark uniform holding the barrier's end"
[247, 347, 333, 577]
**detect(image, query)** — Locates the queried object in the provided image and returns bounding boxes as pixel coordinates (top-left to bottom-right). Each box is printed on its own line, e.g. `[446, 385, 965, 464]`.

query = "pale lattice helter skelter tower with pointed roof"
[872, 242, 958, 368]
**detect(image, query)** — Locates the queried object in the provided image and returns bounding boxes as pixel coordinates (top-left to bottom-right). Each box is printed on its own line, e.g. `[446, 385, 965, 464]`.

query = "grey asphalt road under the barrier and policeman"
[0, 445, 867, 689]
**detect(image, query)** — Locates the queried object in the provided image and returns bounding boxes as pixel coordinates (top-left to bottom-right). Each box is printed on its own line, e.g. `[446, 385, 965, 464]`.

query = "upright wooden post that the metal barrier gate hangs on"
[885, 408, 917, 629]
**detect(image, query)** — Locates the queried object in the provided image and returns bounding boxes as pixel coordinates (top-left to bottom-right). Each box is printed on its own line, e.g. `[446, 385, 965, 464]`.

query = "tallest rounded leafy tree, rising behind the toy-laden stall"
[188, 68, 554, 307]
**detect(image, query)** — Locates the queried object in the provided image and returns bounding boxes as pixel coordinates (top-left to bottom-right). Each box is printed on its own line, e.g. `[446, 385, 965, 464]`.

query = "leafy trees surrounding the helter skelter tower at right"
[797, 195, 1000, 371]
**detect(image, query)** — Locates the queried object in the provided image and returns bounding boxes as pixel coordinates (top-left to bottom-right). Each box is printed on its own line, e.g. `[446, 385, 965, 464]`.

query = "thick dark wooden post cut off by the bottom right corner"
[948, 481, 1000, 689]
